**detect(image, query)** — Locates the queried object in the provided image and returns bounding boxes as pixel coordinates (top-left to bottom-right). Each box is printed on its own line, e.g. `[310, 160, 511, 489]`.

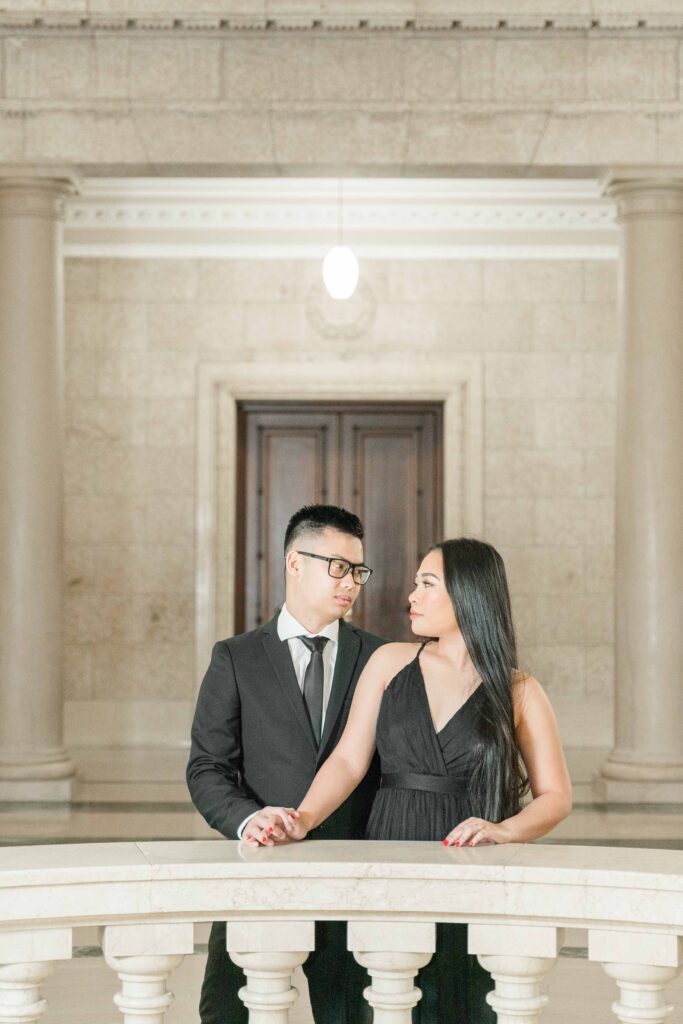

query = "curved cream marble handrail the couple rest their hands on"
[0, 841, 683, 935]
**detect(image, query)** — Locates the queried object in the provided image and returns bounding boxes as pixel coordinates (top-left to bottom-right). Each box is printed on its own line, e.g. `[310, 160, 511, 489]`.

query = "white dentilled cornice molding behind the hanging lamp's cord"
[65, 178, 617, 259]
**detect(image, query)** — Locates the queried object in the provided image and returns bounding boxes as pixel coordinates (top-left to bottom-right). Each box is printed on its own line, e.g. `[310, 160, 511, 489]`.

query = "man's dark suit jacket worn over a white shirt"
[186, 616, 386, 839]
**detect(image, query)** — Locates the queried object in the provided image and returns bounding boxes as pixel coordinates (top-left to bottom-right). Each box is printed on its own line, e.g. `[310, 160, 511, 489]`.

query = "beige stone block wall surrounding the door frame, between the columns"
[65, 253, 616, 745]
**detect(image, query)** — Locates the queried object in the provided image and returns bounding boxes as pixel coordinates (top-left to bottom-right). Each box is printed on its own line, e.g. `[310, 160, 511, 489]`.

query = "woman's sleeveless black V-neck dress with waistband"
[366, 647, 496, 1024]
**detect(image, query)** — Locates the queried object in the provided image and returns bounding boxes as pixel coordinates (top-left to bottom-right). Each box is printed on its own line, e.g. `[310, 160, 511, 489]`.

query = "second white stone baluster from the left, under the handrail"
[100, 924, 195, 1024]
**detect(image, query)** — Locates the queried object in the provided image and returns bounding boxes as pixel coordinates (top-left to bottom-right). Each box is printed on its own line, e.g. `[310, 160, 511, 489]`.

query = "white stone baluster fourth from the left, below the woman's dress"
[347, 921, 436, 1024]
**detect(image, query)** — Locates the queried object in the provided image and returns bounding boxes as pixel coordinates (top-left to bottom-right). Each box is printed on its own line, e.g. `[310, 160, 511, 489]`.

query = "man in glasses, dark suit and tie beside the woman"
[187, 505, 385, 1024]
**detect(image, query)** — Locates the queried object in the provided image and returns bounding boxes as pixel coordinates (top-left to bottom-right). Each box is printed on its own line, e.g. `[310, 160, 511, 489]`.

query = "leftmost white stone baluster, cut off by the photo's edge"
[0, 928, 72, 1024]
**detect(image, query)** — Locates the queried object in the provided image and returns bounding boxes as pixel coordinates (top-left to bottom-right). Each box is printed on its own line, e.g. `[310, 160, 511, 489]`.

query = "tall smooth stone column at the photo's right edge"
[597, 172, 683, 802]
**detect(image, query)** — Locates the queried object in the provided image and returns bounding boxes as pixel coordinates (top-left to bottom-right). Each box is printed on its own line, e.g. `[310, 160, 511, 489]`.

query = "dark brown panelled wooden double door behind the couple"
[236, 401, 442, 640]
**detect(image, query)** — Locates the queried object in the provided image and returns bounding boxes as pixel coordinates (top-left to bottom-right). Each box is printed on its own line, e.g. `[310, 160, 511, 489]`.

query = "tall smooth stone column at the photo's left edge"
[0, 177, 74, 800]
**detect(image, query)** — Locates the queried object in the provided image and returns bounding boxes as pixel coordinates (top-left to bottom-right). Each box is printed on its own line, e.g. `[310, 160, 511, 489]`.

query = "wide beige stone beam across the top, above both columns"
[0, 10, 683, 174]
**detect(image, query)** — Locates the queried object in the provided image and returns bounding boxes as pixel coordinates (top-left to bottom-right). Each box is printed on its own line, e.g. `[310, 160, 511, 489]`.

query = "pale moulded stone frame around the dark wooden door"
[195, 353, 483, 687]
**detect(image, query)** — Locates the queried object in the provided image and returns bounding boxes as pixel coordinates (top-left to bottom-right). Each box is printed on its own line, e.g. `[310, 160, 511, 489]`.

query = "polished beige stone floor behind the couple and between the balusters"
[6, 750, 683, 1024]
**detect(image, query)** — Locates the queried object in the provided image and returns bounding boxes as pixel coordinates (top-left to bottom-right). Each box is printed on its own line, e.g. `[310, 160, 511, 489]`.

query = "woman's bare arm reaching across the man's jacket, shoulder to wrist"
[295, 643, 416, 839]
